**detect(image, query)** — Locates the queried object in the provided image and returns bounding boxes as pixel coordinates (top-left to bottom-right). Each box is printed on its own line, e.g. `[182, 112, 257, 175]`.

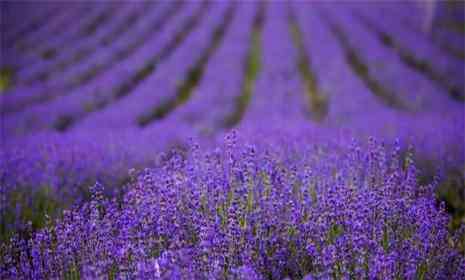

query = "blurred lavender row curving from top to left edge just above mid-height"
[4, 3, 179, 115]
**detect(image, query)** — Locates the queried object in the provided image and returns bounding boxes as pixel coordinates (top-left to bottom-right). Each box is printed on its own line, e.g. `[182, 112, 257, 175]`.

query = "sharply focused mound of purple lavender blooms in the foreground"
[1, 133, 465, 279]
